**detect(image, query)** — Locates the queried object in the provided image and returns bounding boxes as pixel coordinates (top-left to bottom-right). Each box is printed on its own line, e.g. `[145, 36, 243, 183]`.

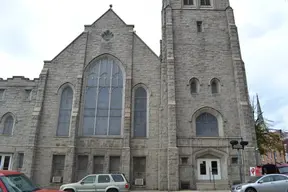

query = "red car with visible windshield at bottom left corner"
[0, 170, 61, 192]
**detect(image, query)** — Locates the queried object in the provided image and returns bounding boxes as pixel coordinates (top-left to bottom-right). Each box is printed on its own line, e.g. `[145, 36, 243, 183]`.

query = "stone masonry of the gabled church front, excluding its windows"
[35, 7, 160, 189]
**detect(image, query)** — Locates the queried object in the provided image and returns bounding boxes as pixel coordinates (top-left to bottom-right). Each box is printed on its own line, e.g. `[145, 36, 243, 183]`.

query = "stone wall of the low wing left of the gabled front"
[0, 76, 39, 174]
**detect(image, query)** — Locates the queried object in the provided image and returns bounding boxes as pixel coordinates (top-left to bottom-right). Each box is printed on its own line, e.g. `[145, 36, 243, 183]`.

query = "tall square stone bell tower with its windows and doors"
[161, 0, 255, 190]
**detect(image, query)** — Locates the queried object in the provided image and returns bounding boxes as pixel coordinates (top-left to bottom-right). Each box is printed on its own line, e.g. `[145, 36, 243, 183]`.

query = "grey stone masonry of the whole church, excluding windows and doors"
[0, 0, 255, 190]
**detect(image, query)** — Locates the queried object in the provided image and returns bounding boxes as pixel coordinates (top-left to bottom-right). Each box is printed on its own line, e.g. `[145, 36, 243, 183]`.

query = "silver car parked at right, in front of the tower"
[231, 174, 288, 192]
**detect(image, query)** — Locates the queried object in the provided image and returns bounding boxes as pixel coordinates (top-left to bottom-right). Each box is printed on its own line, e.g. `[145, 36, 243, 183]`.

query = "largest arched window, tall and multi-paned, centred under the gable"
[82, 56, 124, 136]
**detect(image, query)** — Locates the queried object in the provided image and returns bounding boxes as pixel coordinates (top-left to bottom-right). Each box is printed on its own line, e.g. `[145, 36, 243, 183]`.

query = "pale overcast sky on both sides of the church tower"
[0, 0, 288, 130]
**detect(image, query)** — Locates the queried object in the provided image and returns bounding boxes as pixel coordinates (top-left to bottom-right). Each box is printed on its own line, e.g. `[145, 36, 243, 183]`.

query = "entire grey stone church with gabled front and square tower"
[0, 0, 255, 190]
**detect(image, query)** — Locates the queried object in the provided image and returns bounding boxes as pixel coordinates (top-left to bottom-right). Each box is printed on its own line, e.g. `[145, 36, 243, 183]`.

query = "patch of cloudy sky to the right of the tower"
[231, 0, 288, 129]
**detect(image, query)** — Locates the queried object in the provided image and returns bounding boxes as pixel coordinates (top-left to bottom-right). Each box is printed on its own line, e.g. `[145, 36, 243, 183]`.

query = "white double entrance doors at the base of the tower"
[197, 159, 221, 180]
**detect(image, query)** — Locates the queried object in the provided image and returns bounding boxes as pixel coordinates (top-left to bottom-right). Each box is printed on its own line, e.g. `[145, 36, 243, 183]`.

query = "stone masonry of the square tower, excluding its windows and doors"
[168, 0, 255, 188]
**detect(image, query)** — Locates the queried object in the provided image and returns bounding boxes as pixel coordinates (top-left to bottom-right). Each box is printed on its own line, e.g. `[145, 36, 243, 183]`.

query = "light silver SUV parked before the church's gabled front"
[60, 174, 129, 192]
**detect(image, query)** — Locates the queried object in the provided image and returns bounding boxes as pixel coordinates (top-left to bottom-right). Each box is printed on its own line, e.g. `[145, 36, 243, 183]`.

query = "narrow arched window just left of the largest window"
[56, 86, 73, 136]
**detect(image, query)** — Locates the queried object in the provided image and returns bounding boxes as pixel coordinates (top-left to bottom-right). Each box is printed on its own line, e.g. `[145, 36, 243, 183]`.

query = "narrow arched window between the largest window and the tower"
[133, 87, 147, 137]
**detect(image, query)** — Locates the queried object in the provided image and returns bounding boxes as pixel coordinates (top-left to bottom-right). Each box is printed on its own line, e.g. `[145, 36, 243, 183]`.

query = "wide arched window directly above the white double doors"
[196, 112, 219, 137]
